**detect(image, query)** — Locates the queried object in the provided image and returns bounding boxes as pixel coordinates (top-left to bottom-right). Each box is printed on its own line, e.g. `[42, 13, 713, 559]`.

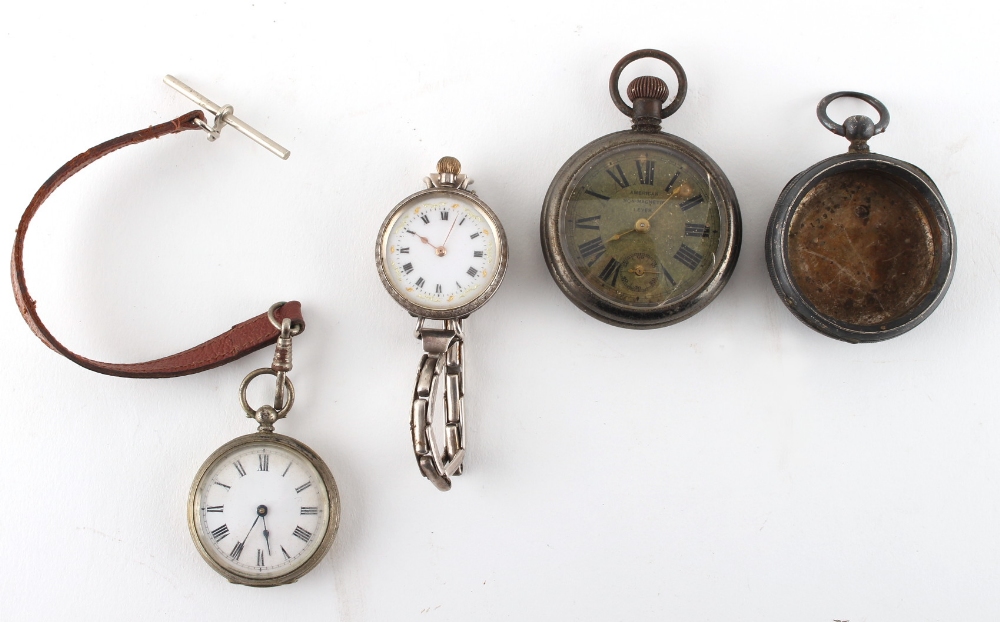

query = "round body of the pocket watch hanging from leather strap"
[189, 434, 339, 586]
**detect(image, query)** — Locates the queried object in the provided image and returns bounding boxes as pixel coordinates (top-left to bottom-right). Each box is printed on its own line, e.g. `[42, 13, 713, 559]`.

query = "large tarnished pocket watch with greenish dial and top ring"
[541, 50, 741, 328]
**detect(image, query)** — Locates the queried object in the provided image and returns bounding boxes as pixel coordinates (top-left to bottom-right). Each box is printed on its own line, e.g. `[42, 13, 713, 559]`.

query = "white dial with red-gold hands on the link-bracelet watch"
[381, 190, 500, 310]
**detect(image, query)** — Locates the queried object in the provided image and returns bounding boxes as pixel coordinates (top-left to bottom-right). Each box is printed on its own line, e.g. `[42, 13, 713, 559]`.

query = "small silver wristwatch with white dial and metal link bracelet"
[375, 157, 507, 490]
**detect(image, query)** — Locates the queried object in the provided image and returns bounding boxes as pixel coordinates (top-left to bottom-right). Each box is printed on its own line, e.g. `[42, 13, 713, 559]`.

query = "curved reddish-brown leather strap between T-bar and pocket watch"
[10, 110, 305, 378]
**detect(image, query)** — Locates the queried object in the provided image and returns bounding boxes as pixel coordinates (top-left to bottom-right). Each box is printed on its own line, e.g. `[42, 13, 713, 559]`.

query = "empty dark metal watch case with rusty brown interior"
[765, 91, 955, 343]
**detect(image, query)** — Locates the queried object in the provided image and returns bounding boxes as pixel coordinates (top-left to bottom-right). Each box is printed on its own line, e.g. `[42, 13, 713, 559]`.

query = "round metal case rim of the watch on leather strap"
[187, 432, 340, 587]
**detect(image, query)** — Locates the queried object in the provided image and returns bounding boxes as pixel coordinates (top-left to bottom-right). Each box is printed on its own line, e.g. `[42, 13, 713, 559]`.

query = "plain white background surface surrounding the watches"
[0, 1, 1000, 622]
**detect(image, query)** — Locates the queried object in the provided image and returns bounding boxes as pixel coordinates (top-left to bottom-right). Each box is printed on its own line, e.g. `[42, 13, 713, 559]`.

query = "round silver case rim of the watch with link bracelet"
[375, 188, 507, 320]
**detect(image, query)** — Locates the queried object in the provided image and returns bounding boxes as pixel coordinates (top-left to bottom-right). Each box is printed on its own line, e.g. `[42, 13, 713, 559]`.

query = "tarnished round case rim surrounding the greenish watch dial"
[541, 130, 743, 329]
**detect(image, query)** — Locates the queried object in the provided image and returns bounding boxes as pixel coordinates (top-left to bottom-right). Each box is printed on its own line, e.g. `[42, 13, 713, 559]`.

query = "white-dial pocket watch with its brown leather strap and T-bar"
[11, 76, 340, 587]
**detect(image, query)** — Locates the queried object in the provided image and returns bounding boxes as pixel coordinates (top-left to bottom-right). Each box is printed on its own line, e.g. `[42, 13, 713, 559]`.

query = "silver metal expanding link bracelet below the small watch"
[410, 318, 465, 490]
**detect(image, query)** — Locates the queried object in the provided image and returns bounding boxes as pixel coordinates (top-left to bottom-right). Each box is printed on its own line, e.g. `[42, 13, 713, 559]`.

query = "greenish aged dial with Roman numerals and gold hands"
[560, 145, 720, 307]
